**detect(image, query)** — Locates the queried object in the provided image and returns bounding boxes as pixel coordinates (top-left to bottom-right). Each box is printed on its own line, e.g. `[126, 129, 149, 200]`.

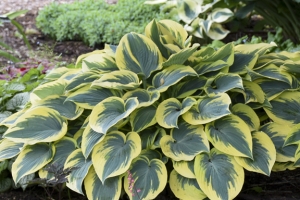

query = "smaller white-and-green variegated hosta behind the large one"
[145, 0, 234, 40]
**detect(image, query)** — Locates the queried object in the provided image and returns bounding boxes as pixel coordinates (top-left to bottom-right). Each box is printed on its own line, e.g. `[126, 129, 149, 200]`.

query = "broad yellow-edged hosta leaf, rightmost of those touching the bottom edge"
[194, 149, 245, 200]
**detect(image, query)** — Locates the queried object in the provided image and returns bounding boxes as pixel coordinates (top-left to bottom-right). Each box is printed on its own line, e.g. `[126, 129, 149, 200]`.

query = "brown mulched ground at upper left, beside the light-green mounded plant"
[0, 0, 93, 66]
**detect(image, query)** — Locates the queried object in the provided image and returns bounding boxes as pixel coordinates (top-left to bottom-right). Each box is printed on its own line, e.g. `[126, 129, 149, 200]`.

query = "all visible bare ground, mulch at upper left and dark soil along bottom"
[0, 0, 300, 200]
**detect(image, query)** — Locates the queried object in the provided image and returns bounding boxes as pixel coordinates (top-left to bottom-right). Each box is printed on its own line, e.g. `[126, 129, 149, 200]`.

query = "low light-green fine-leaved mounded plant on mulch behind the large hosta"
[36, 0, 173, 46]
